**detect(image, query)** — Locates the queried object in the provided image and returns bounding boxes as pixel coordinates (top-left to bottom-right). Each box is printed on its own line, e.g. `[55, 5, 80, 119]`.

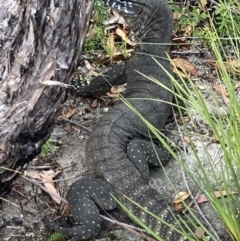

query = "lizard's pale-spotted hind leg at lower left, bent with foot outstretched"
[44, 178, 116, 241]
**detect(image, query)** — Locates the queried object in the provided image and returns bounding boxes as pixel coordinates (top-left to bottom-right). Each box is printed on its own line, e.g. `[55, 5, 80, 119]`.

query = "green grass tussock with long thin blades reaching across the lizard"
[118, 2, 240, 240]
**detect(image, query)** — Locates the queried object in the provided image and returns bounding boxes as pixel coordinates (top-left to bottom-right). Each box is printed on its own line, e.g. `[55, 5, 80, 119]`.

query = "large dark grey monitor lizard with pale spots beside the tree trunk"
[44, 0, 191, 241]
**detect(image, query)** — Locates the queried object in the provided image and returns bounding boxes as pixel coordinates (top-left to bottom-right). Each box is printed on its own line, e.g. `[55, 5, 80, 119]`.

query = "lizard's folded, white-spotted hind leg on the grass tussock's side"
[127, 139, 171, 181]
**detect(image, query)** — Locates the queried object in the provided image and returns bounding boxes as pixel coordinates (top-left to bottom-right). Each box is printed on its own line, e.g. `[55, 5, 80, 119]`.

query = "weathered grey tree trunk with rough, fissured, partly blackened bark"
[0, 0, 94, 196]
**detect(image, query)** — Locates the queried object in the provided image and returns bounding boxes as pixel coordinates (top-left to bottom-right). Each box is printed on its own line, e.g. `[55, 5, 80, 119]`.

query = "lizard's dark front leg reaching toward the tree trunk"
[68, 64, 126, 97]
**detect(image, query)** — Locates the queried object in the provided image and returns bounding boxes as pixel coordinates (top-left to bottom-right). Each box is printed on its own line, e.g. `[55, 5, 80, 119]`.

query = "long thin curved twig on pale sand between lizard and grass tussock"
[173, 109, 221, 241]
